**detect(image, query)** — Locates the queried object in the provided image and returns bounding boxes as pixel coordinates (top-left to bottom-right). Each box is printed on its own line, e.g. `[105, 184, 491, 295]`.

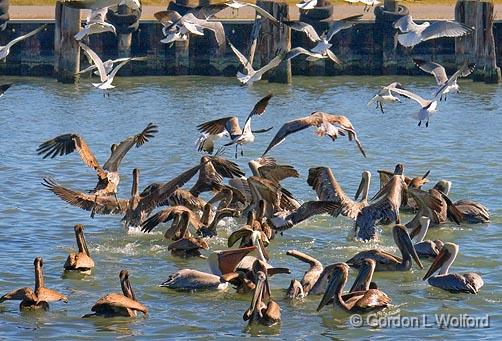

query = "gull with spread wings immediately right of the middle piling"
[283, 15, 362, 64]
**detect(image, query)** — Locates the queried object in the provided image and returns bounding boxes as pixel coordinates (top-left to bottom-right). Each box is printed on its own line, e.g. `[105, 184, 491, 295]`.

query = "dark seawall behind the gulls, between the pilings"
[0, 20, 502, 77]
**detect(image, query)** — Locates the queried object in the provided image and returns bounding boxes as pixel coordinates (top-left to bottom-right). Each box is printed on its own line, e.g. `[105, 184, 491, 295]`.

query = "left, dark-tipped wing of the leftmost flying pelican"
[37, 134, 100, 170]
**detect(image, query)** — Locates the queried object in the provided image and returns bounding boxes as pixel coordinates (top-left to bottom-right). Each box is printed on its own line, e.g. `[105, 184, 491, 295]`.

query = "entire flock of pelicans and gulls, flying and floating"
[0, 0, 490, 326]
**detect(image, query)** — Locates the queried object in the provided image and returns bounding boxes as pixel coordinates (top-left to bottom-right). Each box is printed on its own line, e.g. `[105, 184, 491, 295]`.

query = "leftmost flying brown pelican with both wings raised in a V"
[37, 123, 158, 195]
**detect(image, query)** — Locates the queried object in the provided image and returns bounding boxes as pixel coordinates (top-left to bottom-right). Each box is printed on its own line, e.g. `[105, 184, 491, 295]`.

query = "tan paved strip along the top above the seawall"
[9, 3, 502, 20]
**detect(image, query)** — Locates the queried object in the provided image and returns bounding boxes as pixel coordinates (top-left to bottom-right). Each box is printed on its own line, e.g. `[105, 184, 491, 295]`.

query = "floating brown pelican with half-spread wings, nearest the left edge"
[0, 257, 68, 310]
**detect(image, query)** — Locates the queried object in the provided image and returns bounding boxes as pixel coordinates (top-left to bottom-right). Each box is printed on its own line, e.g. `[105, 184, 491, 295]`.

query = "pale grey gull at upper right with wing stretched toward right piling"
[394, 15, 474, 47]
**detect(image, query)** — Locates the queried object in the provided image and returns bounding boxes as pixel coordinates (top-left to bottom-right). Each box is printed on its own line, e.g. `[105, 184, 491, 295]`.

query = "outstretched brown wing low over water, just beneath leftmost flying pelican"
[42, 178, 128, 214]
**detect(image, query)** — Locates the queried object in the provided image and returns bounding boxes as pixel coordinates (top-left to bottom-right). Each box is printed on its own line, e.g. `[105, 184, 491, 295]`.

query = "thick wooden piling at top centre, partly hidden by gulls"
[256, 0, 292, 83]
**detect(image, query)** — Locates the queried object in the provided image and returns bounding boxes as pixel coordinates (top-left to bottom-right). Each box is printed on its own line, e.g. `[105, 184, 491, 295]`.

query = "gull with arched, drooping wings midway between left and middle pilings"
[154, 10, 225, 52]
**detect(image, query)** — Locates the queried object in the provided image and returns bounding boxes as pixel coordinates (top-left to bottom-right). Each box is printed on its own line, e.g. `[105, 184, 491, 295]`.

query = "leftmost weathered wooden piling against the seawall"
[54, 2, 80, 83]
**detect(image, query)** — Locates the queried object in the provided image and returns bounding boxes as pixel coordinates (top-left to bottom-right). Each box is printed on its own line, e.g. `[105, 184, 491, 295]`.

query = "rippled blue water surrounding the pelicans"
[0, 77, 502, 340]
